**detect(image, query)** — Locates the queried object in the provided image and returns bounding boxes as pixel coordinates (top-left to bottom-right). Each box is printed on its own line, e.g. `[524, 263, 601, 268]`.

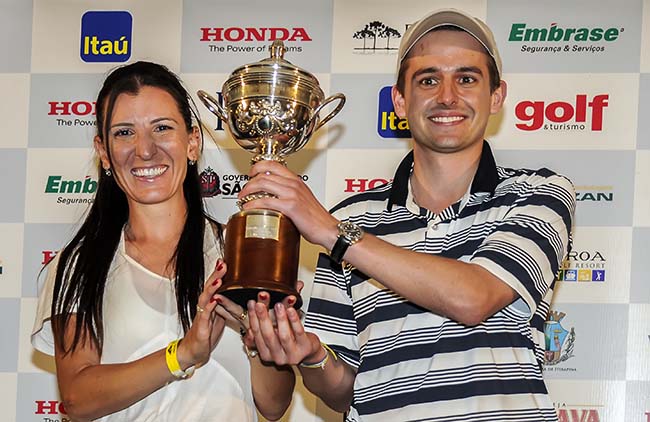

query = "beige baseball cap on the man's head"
[397, 9, 502, 78]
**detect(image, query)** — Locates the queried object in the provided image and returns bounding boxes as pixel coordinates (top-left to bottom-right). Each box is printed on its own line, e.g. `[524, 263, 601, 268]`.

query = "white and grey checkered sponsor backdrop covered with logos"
[0, 0, 650, 422]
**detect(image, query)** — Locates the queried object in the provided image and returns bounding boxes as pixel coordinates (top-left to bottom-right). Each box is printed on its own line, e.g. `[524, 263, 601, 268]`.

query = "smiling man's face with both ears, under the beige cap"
[393, 30, 506, 153]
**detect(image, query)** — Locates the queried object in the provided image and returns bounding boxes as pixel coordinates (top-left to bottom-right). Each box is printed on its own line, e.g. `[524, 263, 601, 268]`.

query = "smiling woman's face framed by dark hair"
[95, 86, 200, 206]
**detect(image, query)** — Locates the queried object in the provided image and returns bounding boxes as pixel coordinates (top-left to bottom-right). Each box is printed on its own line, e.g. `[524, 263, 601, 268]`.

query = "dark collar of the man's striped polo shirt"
[388, 141, 499, 211]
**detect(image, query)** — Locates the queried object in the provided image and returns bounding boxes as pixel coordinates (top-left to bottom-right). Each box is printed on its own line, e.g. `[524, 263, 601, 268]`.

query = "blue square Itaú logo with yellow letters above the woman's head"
[79, 11, 133, 63]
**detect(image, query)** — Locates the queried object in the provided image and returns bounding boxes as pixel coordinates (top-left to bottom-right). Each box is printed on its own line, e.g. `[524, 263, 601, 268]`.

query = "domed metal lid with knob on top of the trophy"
[223, 40, 324, 97]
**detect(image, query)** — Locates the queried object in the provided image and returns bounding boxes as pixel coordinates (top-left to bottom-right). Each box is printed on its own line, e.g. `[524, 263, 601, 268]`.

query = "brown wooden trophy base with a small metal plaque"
[218, 209, 302, 309]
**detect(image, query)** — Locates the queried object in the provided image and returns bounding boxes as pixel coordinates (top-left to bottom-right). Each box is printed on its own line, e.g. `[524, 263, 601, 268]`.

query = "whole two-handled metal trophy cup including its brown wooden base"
[197, 40, 345, 309]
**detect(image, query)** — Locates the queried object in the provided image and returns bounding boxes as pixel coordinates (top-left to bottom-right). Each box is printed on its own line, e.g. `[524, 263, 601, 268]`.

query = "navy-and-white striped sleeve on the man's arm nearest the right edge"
[470, 173, 576, 319]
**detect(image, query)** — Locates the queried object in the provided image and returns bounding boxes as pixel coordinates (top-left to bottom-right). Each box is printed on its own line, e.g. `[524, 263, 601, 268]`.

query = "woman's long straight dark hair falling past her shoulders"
[51, 61, 223, 353]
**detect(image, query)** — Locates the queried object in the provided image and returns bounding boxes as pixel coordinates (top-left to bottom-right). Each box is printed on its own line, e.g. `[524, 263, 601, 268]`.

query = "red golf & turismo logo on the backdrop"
[515, 94, 609, 132]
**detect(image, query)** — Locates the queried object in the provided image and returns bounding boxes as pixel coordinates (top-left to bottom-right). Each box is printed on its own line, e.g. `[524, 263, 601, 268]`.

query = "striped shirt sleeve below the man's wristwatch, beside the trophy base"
[305, 253, 360, 369]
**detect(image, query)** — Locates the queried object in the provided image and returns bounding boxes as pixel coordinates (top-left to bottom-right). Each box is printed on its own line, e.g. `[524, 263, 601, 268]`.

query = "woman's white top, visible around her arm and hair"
[31, 224, 257, 422]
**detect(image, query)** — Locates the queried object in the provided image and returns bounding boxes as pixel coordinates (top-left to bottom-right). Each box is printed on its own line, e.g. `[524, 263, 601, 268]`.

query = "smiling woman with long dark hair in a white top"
[32, 62, 295, 421]
